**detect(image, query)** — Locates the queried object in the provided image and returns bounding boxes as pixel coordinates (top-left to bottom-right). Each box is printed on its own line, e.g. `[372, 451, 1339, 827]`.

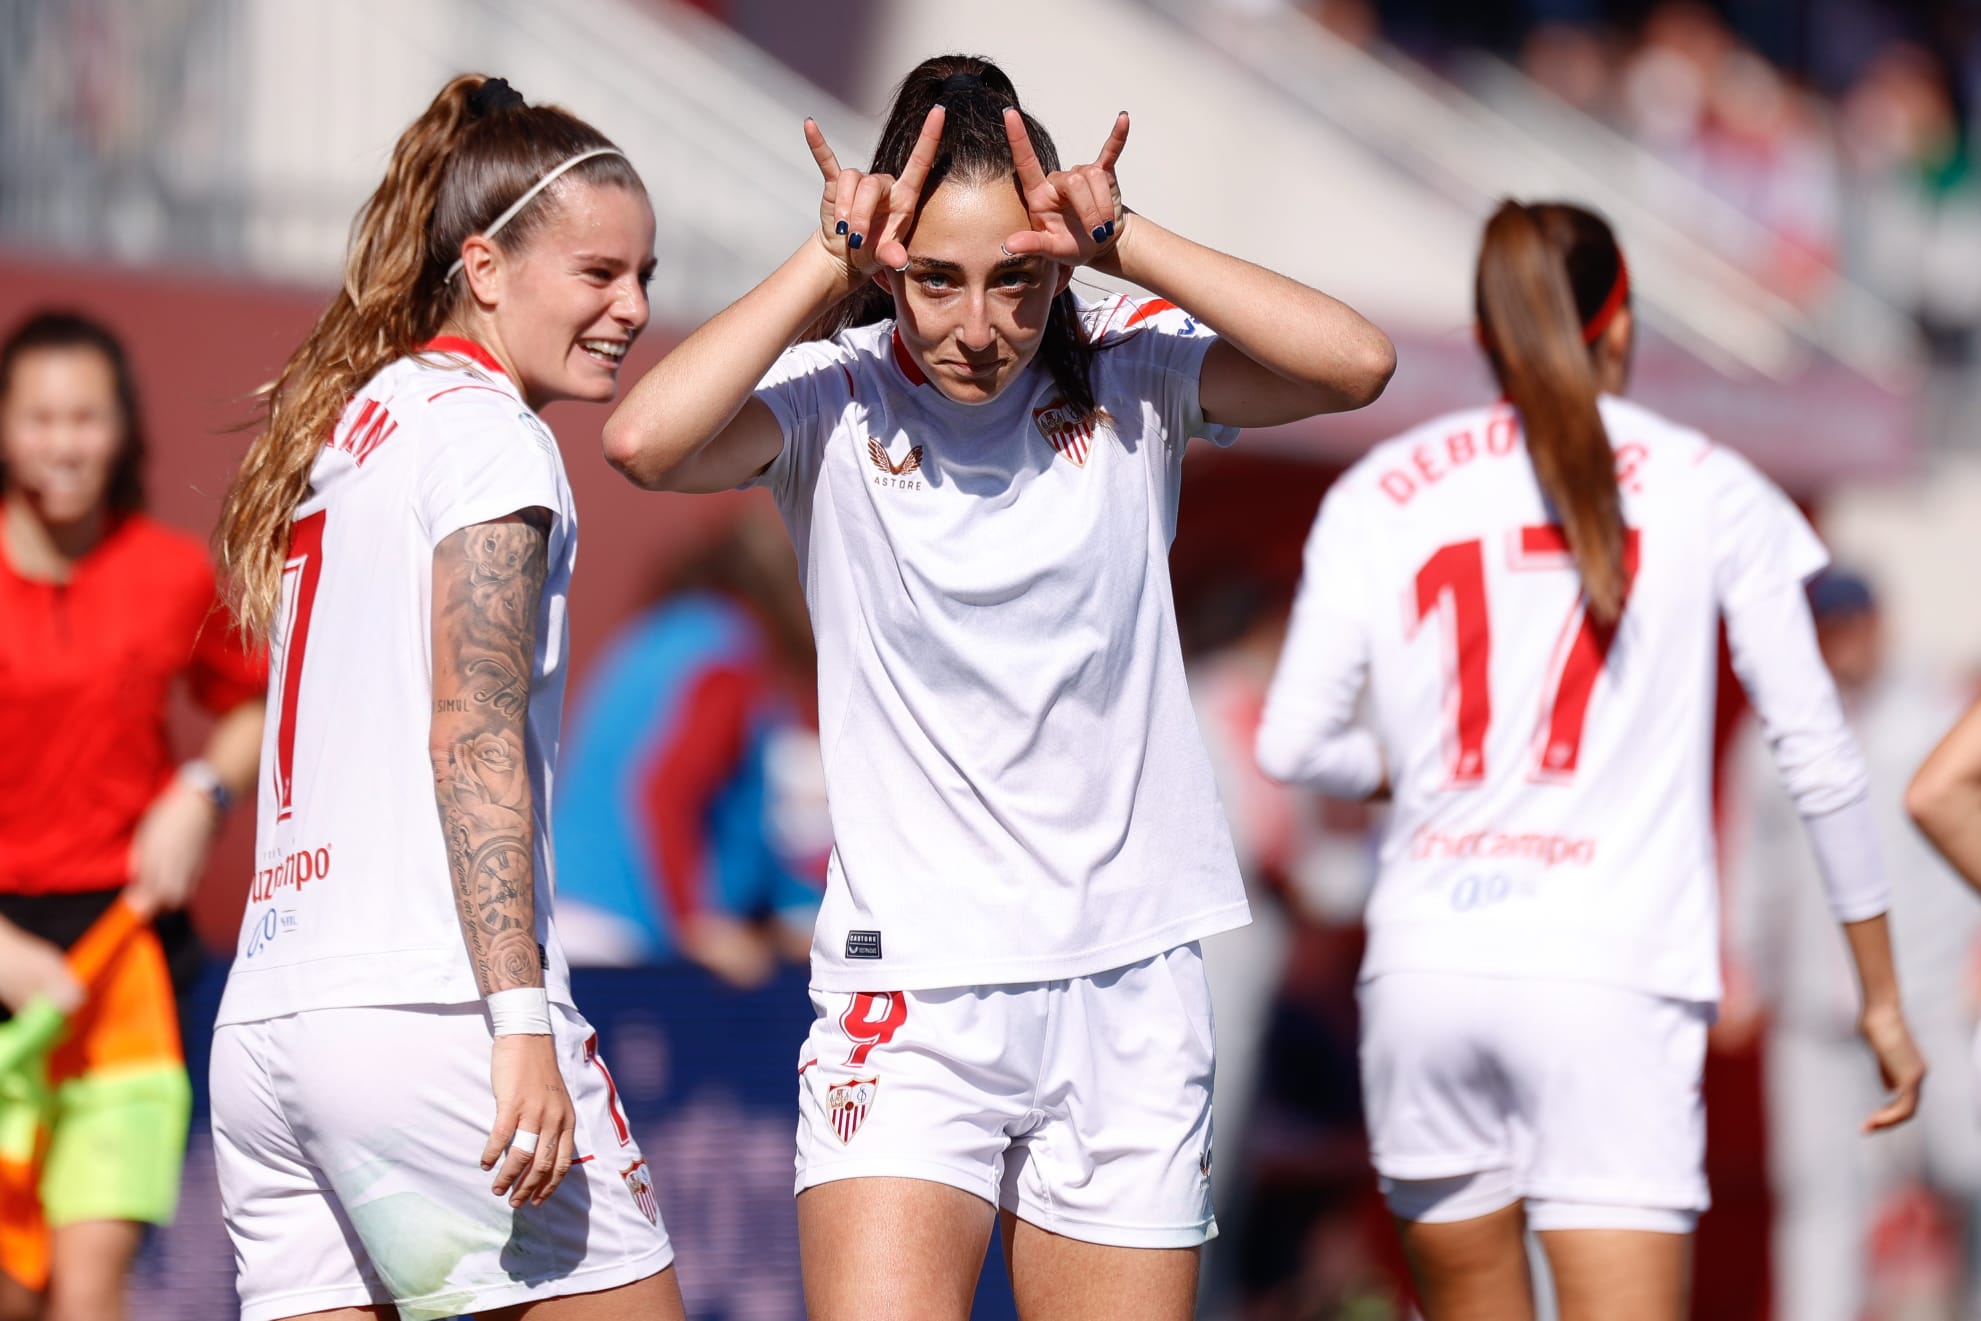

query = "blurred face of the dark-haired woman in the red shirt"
[0, 345, 125, 527]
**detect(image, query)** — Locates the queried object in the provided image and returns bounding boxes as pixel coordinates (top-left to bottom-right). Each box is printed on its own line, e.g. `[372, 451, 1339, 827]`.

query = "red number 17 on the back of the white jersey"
[1410, 525, 1638, 788]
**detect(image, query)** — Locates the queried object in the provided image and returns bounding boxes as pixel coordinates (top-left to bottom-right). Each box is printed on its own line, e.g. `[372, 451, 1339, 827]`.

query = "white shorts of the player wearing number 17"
[1359, 972, 1712, 1234]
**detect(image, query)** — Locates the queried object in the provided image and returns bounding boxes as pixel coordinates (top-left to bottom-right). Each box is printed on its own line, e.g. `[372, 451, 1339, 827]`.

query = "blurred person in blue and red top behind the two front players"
[555, 515, 830, 986]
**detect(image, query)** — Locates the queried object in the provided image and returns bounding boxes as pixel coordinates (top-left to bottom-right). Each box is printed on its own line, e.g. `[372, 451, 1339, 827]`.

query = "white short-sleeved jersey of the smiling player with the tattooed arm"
[220, 339, 578, 1024]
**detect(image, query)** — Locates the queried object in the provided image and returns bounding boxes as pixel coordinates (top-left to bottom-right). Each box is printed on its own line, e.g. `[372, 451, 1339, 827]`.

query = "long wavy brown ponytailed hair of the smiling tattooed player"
[214, 73, 644, 642]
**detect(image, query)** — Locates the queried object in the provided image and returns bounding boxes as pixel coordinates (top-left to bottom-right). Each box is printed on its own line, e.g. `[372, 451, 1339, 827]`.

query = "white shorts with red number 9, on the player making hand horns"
[798, 943, 1218, 1248]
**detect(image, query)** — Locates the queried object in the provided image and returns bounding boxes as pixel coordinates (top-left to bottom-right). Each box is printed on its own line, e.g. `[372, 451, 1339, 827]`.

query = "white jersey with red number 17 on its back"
[1260, 398, 1864, 1000]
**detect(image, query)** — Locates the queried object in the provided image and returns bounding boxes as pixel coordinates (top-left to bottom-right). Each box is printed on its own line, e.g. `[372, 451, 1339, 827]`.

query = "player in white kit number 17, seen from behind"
[1258, 202, 1924, 1321]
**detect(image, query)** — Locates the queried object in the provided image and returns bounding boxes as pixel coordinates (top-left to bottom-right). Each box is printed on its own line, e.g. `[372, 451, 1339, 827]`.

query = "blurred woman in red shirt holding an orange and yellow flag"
[0, 311, 265, 1321]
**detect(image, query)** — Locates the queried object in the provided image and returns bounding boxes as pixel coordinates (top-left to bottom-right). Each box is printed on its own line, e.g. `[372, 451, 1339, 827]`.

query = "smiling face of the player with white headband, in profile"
[477, 180, 654, 408]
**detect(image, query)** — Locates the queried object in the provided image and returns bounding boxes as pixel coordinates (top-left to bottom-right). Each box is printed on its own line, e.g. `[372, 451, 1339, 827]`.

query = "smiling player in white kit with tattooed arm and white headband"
[212, 75, 681, 1321]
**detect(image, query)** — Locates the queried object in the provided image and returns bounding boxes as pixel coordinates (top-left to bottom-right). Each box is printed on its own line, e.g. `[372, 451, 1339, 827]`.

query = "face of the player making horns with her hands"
[878, 178, 1072, 404]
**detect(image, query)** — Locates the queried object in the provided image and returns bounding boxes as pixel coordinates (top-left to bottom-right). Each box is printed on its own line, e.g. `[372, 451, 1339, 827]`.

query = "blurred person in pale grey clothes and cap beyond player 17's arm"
[1725, 568, 1981, 1321]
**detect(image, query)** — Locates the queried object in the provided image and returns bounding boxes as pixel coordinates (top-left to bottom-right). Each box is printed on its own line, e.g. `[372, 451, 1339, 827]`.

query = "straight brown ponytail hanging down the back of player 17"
[1476, 202, 1628, 624]
